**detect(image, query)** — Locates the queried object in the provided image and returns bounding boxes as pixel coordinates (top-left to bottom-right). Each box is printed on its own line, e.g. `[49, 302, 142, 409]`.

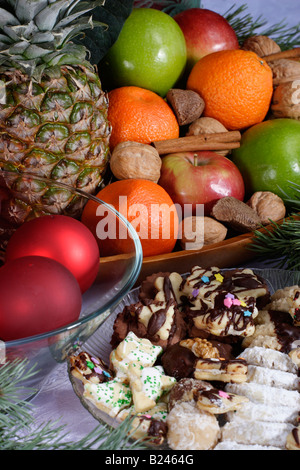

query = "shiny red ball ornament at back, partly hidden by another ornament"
[5, 215, 100, 293]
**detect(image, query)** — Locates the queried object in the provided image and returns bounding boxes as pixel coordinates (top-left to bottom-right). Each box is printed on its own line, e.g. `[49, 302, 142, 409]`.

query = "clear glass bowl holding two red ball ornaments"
[0, 170, 143, 400]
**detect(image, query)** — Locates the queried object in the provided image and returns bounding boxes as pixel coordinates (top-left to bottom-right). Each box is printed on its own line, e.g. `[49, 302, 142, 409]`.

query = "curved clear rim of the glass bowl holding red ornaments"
[0, 168, 143, 348]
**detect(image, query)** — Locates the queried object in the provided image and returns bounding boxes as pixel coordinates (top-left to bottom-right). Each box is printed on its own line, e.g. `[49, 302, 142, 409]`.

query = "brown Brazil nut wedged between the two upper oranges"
[166, 88, 205, 126]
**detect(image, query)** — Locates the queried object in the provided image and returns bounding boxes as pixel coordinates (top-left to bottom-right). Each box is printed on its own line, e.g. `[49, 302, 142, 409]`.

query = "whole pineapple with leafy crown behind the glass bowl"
[0, 0, 111, 250]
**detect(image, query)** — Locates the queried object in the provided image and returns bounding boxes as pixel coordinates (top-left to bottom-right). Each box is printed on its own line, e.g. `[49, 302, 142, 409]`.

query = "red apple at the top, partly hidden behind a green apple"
[174, 8, 239, 72]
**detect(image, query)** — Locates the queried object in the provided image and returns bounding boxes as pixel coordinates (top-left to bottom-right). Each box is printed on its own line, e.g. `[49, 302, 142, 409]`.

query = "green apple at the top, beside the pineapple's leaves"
[99, 8, 186, 97]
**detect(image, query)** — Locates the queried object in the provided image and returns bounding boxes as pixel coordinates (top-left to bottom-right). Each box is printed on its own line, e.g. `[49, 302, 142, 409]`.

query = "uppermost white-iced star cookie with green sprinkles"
[110, 331, 162, 382]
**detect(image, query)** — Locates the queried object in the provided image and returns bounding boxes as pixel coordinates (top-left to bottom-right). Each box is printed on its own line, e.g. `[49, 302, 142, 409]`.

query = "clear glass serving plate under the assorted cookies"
[69, 268, 300, 449]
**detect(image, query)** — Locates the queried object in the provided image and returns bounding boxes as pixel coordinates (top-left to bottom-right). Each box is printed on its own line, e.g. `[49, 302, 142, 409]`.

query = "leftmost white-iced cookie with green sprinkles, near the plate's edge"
[83, 379, 132, 418]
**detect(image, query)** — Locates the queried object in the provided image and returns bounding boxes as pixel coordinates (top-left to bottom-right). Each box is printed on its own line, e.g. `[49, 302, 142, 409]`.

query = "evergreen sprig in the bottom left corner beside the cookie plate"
[0, 360, 145, 450]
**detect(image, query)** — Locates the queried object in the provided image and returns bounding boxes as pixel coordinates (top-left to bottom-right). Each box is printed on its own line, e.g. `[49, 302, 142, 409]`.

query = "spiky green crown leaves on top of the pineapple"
[0, 0, 131, 80]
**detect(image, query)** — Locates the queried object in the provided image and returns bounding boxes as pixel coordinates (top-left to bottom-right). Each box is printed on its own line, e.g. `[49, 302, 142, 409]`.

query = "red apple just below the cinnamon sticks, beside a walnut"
[158, 151, 245, 215]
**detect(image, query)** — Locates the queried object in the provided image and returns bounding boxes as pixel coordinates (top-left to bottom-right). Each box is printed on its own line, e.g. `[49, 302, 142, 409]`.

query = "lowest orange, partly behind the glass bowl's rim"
[81, 179, 179, 256]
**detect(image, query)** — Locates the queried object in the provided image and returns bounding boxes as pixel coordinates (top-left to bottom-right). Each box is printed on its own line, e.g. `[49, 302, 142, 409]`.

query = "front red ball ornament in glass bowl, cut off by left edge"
[0, 256, 82, 341]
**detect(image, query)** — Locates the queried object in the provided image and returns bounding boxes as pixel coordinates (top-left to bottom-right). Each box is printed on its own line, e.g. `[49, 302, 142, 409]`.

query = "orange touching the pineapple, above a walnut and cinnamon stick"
[108, 86, 179, 150]
